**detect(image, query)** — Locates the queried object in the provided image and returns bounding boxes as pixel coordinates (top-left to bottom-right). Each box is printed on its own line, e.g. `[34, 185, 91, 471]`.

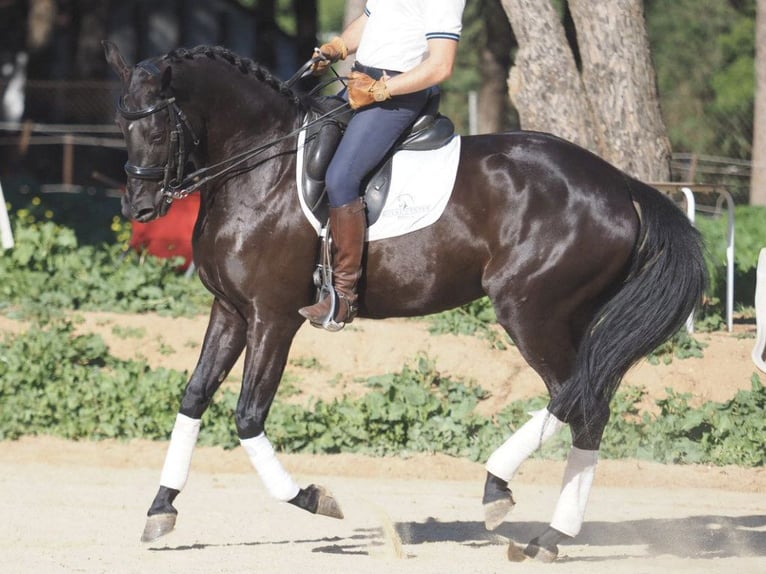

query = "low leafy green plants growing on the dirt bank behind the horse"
[0, 211, 766, 466]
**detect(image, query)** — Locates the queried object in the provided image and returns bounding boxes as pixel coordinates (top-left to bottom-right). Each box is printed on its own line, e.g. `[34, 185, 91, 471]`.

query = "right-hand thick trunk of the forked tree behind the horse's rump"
[569, 0, 670, 181]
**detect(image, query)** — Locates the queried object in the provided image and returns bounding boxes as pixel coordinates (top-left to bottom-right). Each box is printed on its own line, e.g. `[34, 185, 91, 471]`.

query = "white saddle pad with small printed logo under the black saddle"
[296, 131, 460, 241]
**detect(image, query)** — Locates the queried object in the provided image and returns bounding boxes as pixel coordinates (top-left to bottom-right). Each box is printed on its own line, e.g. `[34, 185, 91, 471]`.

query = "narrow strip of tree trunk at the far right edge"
[750, 0, 766, 205]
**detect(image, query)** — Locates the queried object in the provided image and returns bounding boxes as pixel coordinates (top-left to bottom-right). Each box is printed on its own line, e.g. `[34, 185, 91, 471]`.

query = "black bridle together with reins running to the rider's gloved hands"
[117, 58, 348, 203]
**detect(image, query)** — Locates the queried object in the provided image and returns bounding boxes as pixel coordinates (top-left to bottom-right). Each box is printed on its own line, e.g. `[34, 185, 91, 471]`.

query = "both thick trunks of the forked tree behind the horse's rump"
[503, 0, 670, 181]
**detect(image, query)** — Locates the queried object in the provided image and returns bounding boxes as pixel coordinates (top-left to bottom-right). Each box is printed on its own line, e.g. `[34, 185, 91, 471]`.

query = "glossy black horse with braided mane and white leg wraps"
[105, 43, 706, 560]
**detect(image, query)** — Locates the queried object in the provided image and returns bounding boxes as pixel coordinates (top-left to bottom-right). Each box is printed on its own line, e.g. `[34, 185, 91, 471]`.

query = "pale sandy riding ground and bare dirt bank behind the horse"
[0, 313, 766, 574]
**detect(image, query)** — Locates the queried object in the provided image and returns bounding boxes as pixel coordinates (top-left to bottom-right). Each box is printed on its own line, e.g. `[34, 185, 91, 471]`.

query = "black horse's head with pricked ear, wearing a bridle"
[103, 42, 199, 222]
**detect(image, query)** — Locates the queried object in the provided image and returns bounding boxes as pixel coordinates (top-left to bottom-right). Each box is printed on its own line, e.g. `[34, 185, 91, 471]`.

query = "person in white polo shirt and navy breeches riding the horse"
[299, 0, 465, 326]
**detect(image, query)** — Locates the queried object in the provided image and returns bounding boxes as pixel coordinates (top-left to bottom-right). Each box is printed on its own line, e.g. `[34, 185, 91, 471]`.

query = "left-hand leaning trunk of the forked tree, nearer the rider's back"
[502, 0, 598, 151]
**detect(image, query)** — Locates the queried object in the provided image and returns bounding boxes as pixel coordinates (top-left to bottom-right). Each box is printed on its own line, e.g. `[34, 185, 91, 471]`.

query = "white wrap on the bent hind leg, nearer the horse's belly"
[486, 409, 565, 481]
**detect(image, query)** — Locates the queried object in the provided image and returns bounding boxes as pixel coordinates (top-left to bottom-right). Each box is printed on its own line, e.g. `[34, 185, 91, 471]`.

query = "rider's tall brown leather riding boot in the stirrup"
[298, 197, 367, 326]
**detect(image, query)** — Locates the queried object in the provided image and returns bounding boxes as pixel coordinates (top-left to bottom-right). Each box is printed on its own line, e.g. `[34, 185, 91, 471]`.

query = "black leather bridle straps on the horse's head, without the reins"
[117, 92, 199, 203]
